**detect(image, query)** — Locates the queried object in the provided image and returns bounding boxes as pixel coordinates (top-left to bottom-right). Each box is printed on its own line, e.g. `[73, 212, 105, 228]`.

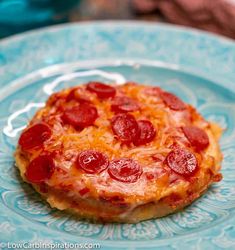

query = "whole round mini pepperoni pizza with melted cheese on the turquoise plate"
[15, 82, 222, 223]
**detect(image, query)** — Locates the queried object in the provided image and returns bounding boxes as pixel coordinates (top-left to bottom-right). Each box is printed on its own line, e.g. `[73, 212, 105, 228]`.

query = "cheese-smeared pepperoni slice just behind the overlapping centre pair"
[111, 96, 140, 113]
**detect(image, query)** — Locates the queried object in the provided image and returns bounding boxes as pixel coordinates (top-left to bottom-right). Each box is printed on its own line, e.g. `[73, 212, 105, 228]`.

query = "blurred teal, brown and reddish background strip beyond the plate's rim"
[0, 0, 235, 39]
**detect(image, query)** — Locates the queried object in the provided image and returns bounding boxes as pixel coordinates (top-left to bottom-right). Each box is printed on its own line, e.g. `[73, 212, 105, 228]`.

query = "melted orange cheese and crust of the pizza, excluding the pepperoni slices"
[15, 83, 222, 223]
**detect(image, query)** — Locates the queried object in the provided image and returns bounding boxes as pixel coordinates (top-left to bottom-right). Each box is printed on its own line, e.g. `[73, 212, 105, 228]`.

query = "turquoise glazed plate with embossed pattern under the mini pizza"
[0, 22, 235, 250]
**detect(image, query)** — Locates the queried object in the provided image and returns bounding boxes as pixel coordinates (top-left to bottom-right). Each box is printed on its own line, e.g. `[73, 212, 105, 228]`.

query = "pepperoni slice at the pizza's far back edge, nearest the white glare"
[87, 82, 116, 99]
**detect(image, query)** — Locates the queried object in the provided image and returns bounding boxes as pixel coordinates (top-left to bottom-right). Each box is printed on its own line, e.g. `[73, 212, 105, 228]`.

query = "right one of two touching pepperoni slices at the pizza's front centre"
[108, 158, 143, 183]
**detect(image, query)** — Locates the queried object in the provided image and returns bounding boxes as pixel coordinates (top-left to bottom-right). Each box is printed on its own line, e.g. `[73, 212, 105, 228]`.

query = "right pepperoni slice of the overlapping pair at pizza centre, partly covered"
[134, 120, 156, 146]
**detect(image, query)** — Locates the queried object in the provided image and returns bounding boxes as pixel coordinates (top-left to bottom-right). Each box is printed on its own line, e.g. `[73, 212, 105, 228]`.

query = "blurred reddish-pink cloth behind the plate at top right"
[132, 0, 235, 38]
